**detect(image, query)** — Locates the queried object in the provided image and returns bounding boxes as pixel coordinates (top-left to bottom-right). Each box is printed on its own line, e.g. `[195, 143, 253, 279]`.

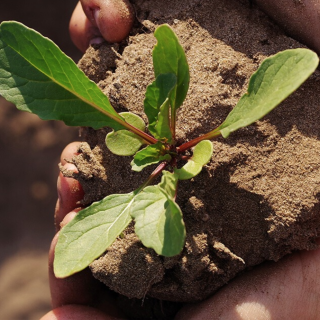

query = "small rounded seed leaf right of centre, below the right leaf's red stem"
[175, 140, 213, 180]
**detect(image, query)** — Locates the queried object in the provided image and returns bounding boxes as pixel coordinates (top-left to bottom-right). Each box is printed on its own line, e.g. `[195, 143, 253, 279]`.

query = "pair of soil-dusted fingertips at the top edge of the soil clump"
[69, 0, 134, 52]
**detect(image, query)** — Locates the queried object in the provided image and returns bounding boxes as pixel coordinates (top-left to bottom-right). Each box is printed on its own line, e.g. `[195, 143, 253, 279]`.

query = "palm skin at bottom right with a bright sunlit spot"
[176, 245, 320, 320]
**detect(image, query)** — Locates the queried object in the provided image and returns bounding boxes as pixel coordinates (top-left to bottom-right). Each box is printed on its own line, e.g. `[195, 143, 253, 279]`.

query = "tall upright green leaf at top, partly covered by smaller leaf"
[153, 25, 190, 115]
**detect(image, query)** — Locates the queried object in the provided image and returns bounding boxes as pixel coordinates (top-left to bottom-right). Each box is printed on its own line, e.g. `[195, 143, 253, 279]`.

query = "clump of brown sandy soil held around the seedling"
[63, 0, 320, 316]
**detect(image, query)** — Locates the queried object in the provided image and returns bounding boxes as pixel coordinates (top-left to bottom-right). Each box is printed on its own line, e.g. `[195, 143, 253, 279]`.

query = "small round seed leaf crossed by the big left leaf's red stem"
[106, 112, 145, 156]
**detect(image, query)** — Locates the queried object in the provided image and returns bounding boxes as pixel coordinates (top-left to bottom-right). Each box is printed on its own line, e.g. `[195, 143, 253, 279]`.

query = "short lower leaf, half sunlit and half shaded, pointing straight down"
[131, 172, 186, 257]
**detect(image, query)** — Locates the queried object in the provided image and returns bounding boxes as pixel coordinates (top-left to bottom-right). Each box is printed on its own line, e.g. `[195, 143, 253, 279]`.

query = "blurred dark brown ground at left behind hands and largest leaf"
[0, 0, 81, 320]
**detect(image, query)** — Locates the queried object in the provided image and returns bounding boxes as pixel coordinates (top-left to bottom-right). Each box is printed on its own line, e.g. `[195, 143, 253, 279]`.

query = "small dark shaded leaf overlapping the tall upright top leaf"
[144, 73, 177, 143]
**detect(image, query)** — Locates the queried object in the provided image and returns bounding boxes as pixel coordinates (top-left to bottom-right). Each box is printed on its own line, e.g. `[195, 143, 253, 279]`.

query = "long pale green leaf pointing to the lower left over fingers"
[54, 192, 135, 278]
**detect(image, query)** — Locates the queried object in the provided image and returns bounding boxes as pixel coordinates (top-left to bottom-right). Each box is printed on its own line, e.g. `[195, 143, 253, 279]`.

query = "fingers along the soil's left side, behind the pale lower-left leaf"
[41, 142, 124, 320]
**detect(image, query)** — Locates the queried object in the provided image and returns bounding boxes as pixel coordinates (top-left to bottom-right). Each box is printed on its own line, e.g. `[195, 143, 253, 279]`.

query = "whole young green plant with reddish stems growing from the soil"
[0, 22, 318, 277]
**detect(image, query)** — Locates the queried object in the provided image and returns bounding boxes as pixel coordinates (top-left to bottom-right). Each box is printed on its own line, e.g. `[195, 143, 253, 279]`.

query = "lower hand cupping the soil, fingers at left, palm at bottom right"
[41, 143, 320, 320]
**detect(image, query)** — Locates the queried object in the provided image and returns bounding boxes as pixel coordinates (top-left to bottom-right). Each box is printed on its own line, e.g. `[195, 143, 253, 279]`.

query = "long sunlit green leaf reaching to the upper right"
[214, 49, 319, 138]
